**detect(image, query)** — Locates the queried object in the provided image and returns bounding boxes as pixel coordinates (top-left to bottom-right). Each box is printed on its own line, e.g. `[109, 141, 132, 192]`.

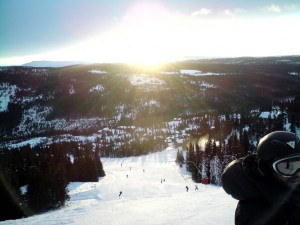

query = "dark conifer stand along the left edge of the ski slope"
[0, 142, 105, 221]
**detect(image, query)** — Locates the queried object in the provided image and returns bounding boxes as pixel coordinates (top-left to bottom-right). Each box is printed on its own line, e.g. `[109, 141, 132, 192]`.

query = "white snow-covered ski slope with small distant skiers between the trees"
[0, 147, 237, 225]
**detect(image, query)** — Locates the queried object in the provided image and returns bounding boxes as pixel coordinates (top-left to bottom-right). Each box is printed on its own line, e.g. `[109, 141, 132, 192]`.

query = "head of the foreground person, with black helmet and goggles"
[257, 131, 300, 185]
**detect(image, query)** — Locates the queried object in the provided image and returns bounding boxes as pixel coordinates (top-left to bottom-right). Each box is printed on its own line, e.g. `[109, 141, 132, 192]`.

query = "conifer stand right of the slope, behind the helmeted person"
[176, 100, 300, 186]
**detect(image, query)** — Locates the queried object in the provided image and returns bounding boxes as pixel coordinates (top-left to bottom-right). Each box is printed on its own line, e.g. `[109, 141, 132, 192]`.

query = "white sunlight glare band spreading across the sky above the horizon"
[7, 2, 300, 67]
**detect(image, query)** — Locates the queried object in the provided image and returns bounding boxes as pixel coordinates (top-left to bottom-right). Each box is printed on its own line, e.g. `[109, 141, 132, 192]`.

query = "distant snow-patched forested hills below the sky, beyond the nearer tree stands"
[0, 57, 300, 149]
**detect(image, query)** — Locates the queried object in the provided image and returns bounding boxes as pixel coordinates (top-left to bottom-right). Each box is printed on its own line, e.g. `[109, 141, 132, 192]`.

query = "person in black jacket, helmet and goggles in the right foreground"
[222, 131, 300, 225]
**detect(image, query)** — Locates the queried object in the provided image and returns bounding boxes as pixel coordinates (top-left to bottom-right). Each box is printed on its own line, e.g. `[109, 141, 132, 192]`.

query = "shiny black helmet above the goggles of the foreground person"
[257, 131, 300, 161]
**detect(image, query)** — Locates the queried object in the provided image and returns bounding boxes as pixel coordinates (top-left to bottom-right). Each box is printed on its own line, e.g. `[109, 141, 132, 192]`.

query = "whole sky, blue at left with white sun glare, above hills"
[0, 0, 300, 65]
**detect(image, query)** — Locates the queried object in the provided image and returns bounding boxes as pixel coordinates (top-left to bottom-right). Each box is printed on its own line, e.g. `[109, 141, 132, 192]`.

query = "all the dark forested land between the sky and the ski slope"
[0, 56, 300, 220]
